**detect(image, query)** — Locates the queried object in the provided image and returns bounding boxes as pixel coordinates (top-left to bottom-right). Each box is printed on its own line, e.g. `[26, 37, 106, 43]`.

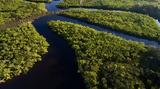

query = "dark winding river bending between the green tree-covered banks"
[0, 0, 160, 89]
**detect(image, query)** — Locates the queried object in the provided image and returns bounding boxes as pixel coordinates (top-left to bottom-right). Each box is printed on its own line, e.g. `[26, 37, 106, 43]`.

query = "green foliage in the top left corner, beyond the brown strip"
[0, 0, 46, 25]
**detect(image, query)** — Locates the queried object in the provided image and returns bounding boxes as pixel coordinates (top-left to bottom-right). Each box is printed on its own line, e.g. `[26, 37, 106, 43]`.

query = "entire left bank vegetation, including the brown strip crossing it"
[0, 0, 49, 84]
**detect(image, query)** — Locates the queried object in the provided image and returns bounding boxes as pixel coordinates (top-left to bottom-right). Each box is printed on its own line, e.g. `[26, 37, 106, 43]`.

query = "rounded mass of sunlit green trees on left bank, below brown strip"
[0, 23, 48, 83]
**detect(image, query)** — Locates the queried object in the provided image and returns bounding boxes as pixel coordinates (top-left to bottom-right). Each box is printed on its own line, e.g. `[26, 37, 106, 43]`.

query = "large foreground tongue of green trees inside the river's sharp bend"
[49, 21, 160, 89]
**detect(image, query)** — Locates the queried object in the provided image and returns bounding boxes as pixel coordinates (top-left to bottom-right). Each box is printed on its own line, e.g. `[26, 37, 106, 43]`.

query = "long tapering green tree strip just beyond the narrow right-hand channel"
[58, 9, 160, 41]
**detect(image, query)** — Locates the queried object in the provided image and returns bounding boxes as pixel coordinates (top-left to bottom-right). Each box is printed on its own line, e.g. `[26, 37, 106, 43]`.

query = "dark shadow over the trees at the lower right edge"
[140, 48, 160, 89]
